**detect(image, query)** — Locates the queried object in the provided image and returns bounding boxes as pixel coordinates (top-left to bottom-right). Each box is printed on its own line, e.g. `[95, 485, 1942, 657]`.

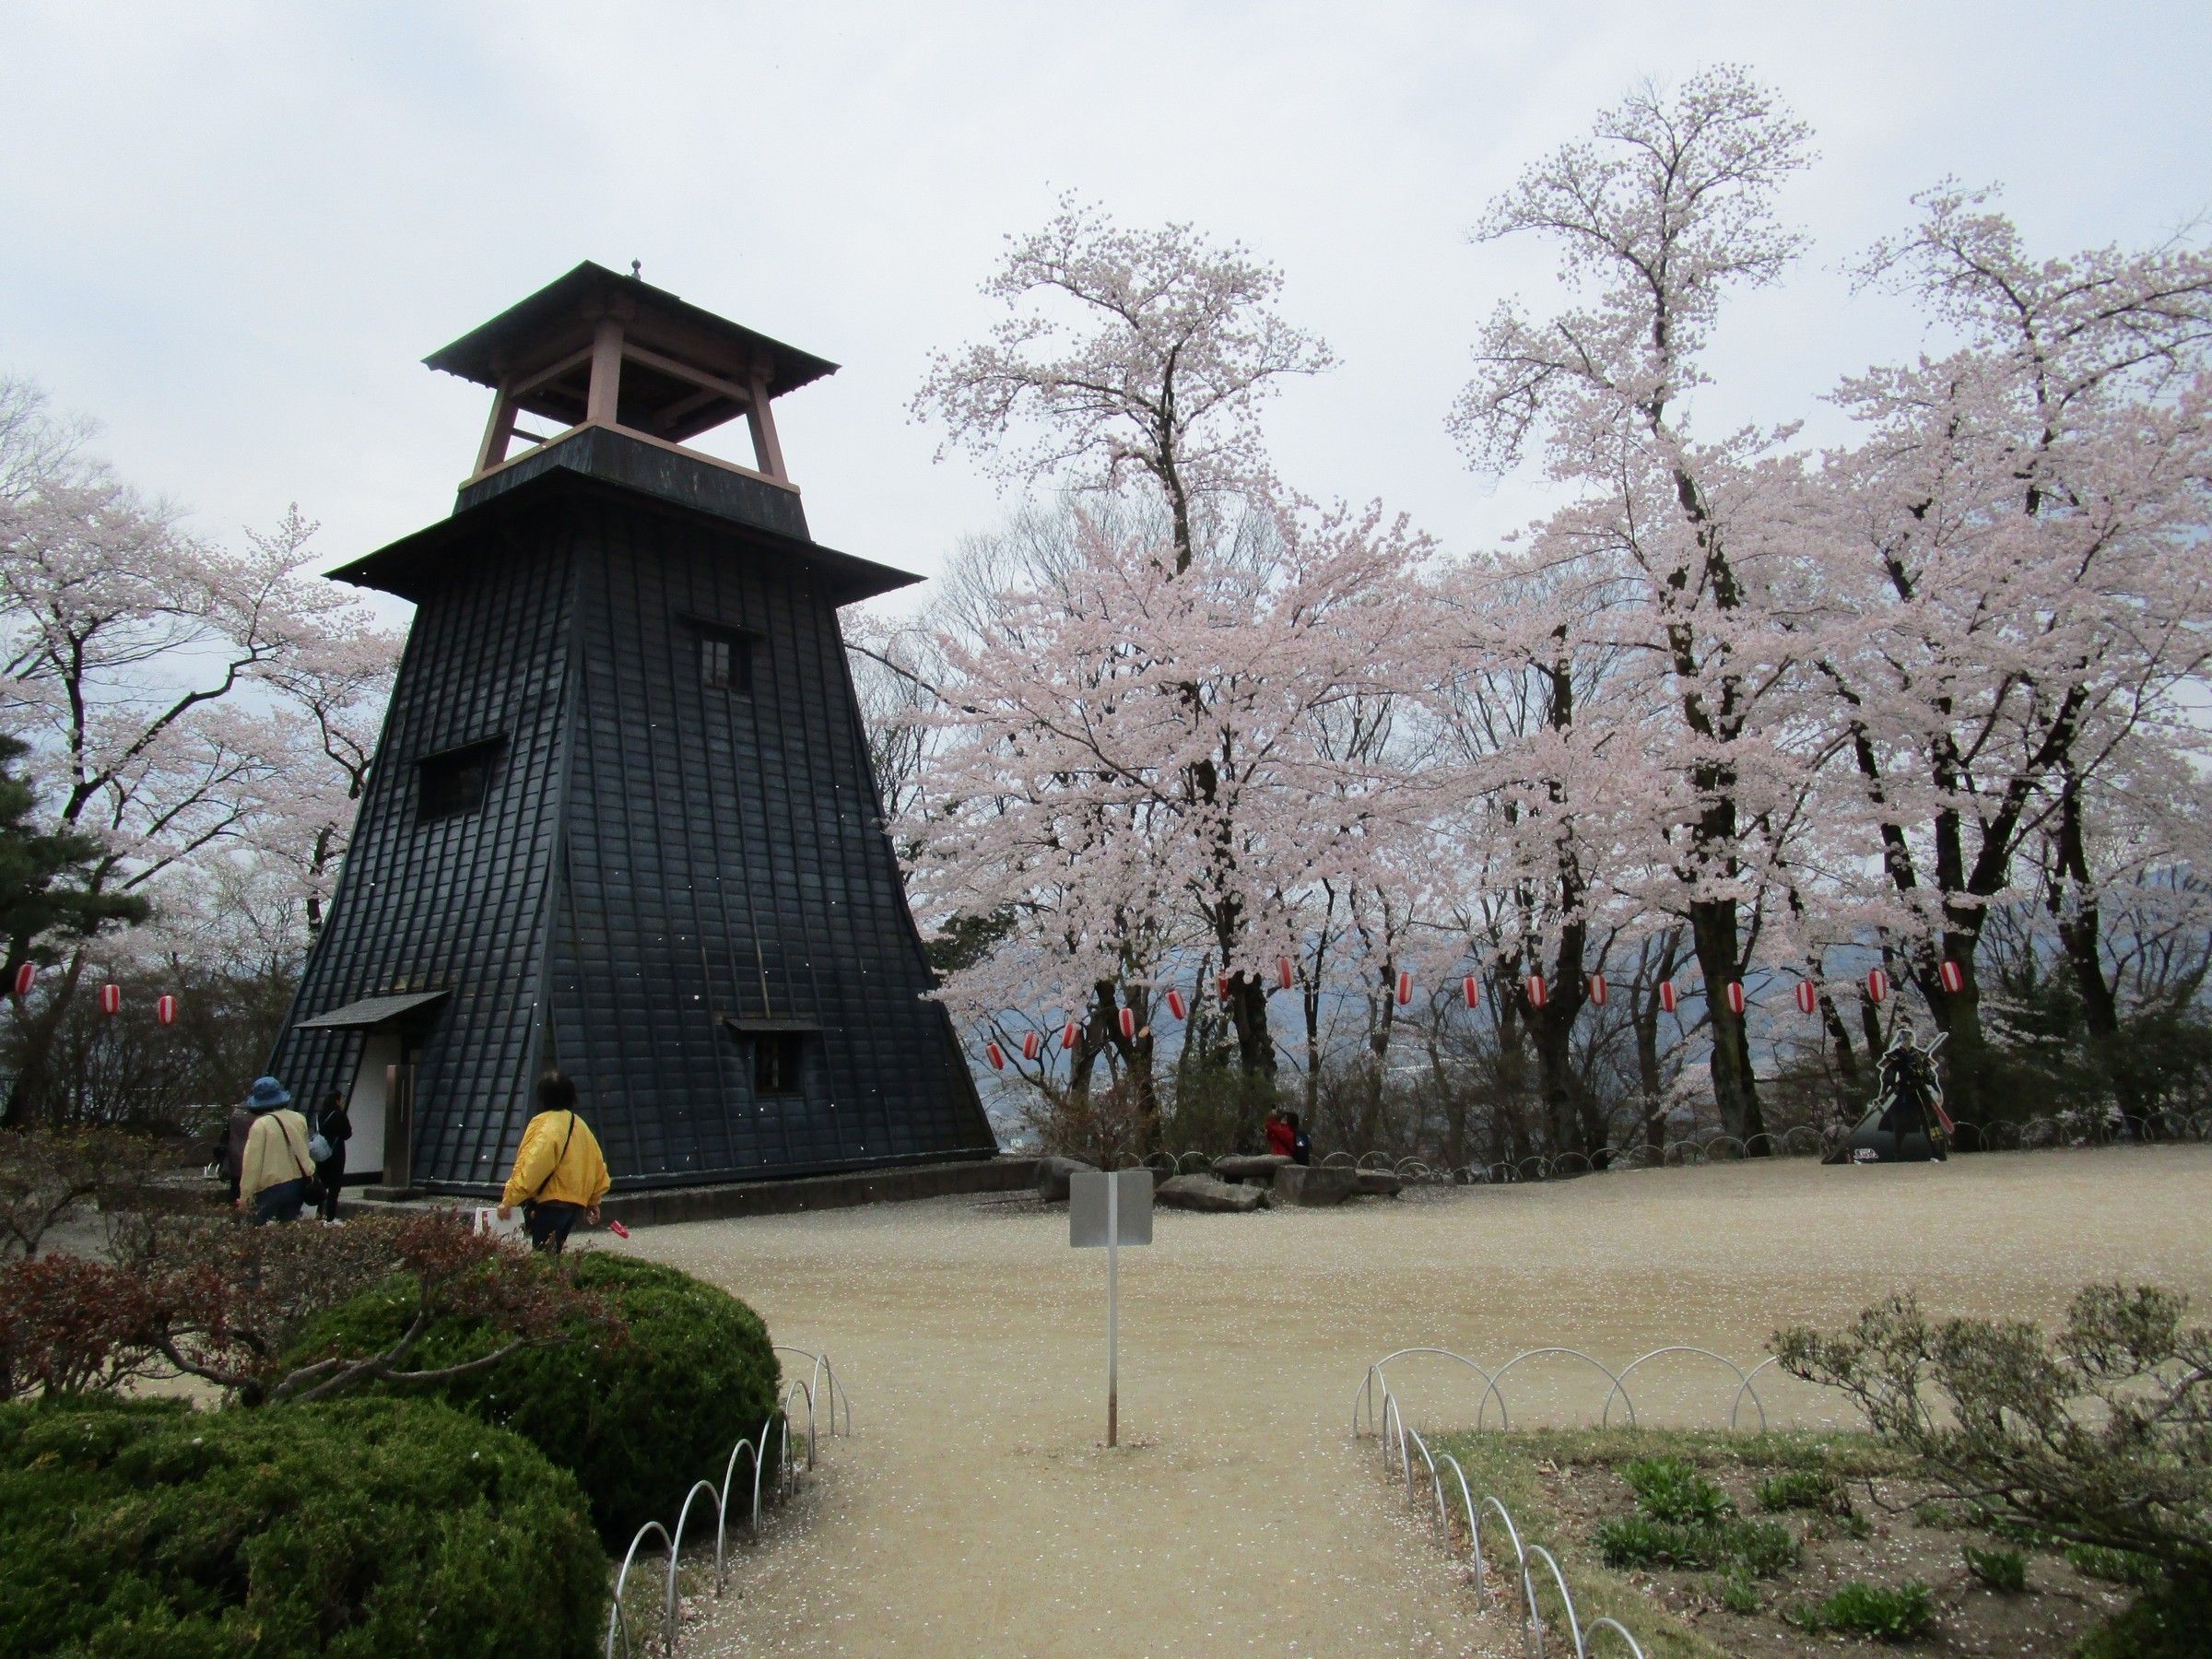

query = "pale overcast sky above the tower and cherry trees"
[0, 0, 2212, 623]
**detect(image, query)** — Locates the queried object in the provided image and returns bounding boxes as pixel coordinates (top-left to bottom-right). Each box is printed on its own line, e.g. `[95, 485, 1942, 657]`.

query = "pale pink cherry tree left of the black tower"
[0, 382, 392, 1112]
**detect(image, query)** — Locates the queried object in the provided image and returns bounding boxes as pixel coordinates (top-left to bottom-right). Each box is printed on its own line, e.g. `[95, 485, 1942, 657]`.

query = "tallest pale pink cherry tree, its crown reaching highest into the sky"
[1453, 66, 1809, 1141]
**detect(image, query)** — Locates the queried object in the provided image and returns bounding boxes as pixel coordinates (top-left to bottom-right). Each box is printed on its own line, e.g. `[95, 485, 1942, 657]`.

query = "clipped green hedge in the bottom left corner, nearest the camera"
[0, 1400, 608, 1659]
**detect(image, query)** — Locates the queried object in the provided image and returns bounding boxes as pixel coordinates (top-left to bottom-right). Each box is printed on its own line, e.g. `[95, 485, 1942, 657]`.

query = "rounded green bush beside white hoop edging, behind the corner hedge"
[292, 1250, 782, 1553]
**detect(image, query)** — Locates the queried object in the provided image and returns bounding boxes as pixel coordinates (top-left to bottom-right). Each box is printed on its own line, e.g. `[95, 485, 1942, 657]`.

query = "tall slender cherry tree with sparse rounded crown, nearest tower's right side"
[913, 197, 1332, 1071]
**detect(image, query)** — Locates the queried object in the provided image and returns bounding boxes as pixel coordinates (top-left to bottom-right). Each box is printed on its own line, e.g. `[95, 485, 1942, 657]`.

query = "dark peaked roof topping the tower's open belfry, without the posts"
[422, 259, 836, 442]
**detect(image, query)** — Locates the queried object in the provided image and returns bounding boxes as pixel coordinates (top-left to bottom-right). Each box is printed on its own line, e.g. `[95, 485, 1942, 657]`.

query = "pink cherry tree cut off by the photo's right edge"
[1820, 186, 2212, 1117]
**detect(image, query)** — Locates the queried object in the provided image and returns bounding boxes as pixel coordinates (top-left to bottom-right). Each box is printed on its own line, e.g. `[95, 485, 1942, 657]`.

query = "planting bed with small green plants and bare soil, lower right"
[1416, 1429, 2132, 1659]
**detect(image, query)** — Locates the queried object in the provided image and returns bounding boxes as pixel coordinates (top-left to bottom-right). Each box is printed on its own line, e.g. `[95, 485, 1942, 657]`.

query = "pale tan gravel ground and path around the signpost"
[606, 1146, 2212, 1654]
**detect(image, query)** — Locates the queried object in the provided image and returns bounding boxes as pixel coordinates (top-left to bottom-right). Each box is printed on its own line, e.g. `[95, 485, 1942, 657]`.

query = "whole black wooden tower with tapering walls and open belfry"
[272, 264, 995, 1193]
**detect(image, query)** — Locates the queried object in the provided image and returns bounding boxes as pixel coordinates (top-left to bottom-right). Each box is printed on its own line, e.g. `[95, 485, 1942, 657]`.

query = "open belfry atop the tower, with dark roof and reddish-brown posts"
[422, 259, 836, 491]
